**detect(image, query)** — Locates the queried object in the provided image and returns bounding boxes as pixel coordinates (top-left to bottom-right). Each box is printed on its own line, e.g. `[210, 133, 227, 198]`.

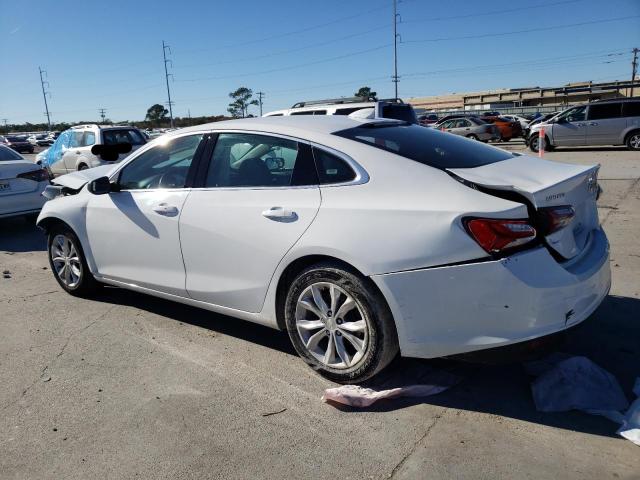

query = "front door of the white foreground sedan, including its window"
[86, 134, 202, 296]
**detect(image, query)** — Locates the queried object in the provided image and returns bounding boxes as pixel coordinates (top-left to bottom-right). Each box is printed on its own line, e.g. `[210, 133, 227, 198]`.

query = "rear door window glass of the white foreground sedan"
[205, 133, 317, 188]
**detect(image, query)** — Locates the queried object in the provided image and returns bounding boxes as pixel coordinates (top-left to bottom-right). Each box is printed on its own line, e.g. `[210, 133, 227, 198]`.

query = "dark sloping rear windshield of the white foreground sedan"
[334, 123, 513, 169]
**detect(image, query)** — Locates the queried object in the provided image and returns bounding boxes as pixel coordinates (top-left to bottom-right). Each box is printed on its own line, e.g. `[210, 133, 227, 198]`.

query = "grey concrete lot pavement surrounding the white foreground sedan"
[0, 148, 640, 479]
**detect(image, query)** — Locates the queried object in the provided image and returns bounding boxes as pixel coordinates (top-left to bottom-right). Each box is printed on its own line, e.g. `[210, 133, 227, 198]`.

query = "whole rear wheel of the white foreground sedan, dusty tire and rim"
[284, 262, 399, 383]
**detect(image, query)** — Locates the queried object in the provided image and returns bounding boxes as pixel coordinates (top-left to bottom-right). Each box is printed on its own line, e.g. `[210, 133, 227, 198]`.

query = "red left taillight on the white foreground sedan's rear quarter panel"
[465, 218, 536, 254]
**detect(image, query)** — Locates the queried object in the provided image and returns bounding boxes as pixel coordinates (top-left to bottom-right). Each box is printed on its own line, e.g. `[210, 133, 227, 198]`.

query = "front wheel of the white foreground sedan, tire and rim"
[47, 225, 101, 297]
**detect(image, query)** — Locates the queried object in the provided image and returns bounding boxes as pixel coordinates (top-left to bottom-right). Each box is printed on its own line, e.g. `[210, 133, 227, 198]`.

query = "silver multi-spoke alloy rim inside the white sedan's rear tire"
[295, 282, 369, 369]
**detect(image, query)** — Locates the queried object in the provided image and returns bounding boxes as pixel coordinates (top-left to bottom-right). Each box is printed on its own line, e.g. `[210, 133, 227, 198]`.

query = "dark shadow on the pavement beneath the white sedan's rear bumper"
[333, 296, 640, 438]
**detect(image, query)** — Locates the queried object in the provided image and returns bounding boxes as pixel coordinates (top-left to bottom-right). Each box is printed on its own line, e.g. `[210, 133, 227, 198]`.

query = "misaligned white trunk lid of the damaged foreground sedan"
[448, 155, 600, 260]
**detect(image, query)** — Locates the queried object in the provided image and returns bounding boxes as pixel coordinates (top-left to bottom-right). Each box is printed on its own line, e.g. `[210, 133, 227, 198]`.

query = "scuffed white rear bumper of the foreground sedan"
[371, 229, 611, 358]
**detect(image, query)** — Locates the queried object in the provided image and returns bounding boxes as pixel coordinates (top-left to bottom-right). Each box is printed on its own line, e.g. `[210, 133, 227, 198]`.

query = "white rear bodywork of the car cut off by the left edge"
[0, 160, 49, 217]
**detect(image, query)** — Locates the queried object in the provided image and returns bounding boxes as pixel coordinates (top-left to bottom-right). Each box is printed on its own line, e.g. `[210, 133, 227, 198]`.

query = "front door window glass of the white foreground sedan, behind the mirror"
[118, 135, 202, 190]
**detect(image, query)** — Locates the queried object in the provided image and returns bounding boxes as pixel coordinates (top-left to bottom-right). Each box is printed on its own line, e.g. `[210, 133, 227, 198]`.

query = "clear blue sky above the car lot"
[0, 0, 640, 123]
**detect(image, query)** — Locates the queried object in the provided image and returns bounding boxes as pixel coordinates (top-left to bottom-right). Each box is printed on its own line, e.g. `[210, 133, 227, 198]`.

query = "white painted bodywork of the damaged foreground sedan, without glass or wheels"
[38, 116, 610, 358]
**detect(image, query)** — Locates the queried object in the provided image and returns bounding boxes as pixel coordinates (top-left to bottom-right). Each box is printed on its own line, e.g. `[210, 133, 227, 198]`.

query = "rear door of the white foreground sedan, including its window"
[180, 133, 320, 312]
